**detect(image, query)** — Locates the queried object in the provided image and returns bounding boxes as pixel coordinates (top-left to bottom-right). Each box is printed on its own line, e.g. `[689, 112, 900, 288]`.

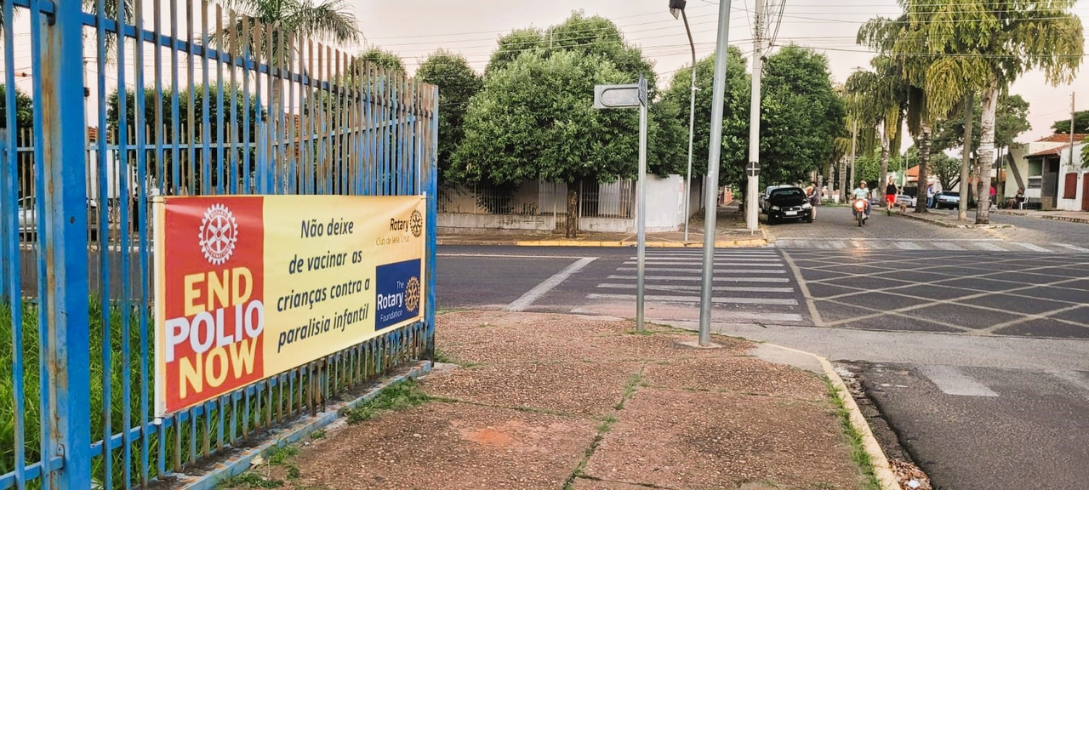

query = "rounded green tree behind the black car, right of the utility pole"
[760, 45, 846, 190]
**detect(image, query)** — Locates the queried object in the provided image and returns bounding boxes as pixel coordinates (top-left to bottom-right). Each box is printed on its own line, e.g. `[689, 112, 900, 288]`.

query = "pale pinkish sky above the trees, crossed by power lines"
[348, 0, 1089, 137]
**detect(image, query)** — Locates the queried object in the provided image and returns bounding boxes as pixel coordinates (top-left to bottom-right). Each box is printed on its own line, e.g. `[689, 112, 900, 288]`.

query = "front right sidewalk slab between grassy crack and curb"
[584, 389, 862, 489]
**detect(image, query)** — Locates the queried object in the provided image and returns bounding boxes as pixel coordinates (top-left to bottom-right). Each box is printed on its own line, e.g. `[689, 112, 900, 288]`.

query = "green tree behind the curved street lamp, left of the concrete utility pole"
[654, 48, 751, 191]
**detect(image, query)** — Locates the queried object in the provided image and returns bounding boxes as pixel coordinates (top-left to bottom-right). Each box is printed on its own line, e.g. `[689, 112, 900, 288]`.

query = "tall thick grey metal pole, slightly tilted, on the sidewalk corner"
[699, 0, 731, 348]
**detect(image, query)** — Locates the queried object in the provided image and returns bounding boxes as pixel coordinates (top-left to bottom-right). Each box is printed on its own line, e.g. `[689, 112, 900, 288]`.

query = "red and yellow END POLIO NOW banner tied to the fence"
[155, 195, 430, 416]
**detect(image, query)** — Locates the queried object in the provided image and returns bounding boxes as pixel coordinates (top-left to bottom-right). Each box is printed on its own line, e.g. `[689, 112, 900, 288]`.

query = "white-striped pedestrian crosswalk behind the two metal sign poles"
[588, 248, 804, 324]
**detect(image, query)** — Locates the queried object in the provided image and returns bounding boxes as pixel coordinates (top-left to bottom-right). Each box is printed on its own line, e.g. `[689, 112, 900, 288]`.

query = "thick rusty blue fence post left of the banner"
[40, 2, 92, 489]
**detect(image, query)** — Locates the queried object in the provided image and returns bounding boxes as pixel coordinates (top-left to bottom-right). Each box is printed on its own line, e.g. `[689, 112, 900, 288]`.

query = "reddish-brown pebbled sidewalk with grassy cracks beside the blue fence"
[225, 312, 901, 490]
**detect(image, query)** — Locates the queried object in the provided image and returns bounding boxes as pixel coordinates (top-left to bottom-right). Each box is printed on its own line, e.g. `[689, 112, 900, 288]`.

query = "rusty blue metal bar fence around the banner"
[0, 0, 438, 489]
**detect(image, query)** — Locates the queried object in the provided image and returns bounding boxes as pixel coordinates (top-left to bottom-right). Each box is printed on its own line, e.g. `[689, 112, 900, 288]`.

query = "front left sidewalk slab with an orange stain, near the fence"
[296, 402, 597, 489]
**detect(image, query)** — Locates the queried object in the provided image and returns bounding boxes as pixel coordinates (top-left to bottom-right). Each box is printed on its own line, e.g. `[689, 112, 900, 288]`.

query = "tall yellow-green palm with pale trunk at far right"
[901, 0, 1085, 224]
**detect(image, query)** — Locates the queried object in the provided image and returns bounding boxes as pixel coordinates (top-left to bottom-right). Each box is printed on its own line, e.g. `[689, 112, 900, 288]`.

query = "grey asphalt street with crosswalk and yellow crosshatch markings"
[438, 208, 1089, 489]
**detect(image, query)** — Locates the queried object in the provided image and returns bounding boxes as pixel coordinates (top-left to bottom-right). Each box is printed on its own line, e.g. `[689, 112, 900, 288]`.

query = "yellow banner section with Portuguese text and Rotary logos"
[265, 196, 427, 374]
